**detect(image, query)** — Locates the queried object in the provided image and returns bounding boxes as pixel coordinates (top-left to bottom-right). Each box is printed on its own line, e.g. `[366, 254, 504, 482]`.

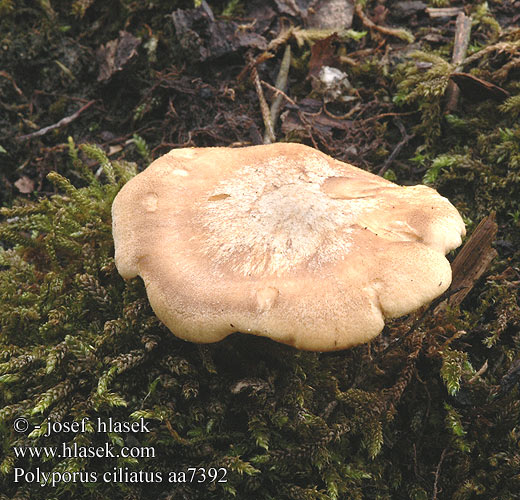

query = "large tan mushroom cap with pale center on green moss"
[112, 143, 465, 351]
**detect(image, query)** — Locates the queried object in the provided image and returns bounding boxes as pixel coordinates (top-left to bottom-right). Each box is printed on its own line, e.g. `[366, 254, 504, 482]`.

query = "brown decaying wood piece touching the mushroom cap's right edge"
[448, 213, 498, 305]
